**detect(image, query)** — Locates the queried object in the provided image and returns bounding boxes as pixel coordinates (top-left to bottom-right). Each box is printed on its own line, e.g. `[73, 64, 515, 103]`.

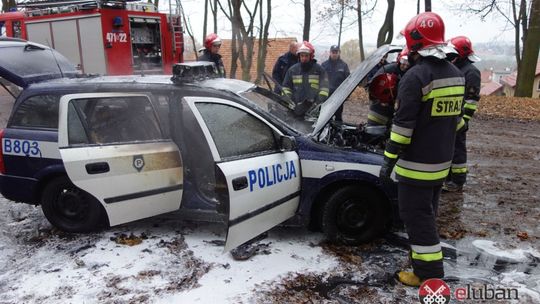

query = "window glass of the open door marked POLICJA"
[196, 103, 278, 158]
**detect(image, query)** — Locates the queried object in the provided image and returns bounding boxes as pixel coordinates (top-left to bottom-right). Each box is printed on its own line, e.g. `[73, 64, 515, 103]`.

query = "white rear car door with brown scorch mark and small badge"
[58, 93, 183, 226]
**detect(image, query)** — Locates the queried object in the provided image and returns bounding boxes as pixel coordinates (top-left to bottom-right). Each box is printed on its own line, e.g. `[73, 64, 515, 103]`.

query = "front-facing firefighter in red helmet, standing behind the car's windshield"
[282, 41, 328, 116]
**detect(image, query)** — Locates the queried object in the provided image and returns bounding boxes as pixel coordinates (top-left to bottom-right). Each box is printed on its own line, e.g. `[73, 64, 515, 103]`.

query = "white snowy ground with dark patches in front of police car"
[0, 199, 540, 303]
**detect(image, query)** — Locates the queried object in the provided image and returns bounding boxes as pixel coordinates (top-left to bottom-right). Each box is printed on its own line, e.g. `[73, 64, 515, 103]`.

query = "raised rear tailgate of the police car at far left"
[0, 38, 78, 88]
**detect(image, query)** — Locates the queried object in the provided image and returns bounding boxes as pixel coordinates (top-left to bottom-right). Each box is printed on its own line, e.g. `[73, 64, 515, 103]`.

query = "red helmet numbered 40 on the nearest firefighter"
[401, 12, 444, 52]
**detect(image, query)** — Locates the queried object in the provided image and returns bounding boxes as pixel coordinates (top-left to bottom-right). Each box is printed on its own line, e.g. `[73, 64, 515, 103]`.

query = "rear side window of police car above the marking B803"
[11, 95, 60, 129]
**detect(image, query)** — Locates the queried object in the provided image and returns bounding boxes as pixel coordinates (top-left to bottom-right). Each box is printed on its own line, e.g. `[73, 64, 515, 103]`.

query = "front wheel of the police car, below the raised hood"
[322, 185, 390, 245]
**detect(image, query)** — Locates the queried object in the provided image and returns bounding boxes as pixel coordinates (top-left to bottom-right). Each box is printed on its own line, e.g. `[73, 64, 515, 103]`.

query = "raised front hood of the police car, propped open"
[311, 44, 402, 135]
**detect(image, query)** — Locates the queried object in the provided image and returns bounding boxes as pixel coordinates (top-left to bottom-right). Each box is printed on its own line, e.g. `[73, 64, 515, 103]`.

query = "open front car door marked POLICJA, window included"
[184, 97, 301, 251]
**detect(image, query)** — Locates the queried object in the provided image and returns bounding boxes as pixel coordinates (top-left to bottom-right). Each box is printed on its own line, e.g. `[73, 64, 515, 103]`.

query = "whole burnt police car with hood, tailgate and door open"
[0, 40, 396, 250]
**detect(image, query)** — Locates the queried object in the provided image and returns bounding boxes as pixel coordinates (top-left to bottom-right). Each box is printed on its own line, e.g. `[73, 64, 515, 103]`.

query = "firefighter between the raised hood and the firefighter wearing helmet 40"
[367, 47, 409, 127]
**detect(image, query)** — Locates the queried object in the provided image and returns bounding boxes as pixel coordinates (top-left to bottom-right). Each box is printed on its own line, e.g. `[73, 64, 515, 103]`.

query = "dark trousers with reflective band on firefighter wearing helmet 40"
[398, 182, 444, 280]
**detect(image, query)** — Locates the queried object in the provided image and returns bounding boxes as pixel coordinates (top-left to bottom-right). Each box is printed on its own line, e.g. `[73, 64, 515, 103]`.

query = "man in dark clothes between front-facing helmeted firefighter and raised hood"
[321, 45, 351, 122]
